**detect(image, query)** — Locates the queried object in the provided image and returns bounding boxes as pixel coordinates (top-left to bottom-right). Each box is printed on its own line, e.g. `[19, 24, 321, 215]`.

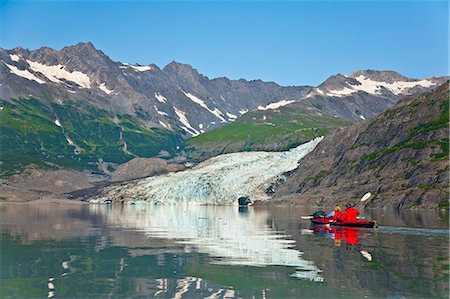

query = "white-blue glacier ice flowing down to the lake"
[95, 137, 322, 205]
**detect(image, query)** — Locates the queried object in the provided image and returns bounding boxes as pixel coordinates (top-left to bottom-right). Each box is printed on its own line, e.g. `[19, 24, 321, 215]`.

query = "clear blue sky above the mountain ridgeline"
[0, 0, 449, 85]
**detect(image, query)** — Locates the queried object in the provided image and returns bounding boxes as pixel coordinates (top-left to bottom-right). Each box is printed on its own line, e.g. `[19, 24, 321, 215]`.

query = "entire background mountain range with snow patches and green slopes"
[0, 42, 446, 174]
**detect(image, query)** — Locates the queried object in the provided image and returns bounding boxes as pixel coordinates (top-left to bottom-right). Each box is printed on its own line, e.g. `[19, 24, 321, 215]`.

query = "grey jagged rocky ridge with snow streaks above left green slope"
[0, 43, 310, 137]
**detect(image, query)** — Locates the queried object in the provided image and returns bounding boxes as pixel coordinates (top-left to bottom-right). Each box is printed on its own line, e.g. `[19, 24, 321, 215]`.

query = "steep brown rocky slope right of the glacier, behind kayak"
[273, 82, 449, 208]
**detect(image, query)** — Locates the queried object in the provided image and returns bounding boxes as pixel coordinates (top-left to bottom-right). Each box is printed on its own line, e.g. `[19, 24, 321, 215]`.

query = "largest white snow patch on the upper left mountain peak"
[27, 60, 91, 88]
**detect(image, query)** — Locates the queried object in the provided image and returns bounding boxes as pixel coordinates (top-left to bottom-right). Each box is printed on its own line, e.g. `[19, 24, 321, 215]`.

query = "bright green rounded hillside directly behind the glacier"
[186, 107, 349, 159]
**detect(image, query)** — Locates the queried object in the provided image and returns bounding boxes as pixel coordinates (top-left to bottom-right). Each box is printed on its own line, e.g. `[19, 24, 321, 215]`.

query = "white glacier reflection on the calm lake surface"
[90, 204, 323, 282]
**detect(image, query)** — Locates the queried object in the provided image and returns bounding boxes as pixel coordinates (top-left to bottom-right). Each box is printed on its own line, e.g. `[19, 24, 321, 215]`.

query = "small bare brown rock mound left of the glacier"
[111, 158, 168, 182]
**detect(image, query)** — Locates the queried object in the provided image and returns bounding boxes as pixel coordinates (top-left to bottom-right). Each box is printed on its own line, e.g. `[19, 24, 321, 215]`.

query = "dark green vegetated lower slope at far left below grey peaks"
[0, 99, 182, 175]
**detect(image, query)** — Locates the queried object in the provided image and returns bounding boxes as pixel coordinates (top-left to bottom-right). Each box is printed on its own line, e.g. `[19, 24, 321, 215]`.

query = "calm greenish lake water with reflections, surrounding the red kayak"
[0, 203, 449, 298]
